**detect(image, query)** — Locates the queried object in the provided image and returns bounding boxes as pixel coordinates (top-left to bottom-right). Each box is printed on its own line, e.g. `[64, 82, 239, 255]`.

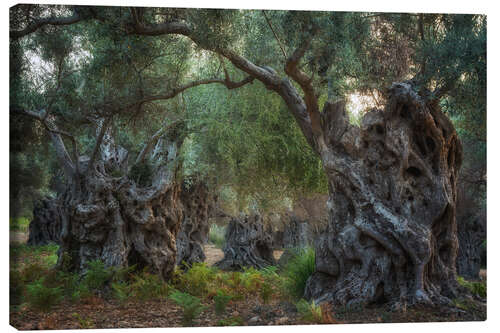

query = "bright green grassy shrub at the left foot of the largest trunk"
[284, 248, 315, 298]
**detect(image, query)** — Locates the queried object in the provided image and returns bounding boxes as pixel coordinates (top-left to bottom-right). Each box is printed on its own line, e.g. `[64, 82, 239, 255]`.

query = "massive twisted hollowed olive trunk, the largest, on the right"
[305, 83, 462, 306]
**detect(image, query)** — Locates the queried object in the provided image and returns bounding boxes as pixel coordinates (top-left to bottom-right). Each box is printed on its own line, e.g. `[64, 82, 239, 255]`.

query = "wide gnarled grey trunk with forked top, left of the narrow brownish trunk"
[58, 123, 183, 279]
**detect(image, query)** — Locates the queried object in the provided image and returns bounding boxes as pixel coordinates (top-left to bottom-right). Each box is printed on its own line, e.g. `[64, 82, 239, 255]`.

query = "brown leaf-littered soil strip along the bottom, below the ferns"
[10, 297, 486, 330]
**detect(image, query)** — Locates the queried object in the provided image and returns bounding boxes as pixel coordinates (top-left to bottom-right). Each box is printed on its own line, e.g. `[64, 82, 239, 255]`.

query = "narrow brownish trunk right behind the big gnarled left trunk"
[177, 182, 214, 267]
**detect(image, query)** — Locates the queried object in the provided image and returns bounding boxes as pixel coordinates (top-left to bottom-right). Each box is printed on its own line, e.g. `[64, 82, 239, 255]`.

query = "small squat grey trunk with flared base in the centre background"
[215, 215, 274, 270]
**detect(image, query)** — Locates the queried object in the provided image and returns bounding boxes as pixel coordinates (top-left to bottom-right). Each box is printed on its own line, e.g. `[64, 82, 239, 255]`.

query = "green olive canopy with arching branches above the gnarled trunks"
[10, 5, 486, 218]
